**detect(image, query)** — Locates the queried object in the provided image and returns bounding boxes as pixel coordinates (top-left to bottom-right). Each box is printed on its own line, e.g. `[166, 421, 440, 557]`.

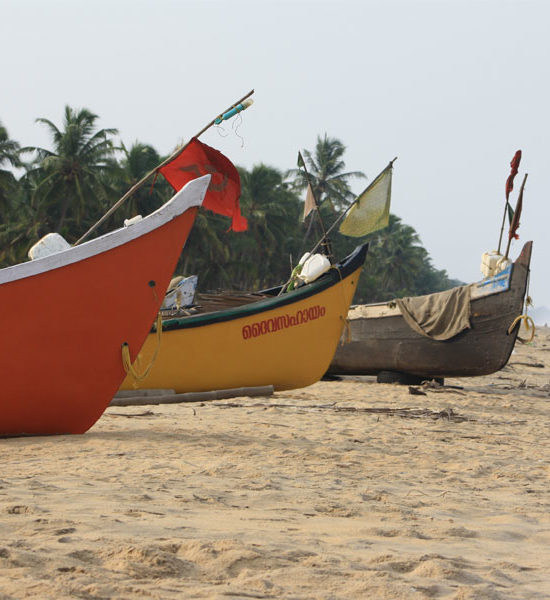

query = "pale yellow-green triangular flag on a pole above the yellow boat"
[339, 163, 393, 237]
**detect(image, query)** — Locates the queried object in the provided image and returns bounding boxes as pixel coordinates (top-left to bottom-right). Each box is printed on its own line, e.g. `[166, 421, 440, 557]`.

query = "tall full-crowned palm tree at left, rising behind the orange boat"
[25, 106, 117, 237]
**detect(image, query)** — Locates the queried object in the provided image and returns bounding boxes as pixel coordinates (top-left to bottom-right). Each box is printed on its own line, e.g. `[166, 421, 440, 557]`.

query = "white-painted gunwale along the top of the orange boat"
[0, 175, 210, 286]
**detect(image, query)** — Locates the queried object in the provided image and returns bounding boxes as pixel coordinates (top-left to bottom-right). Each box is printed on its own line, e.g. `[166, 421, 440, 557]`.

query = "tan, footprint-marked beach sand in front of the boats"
[0, 329, 550, 600]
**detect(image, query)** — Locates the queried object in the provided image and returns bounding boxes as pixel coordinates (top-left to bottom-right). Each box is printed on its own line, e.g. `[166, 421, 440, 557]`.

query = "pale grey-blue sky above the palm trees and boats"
[0, 0, 550, 307]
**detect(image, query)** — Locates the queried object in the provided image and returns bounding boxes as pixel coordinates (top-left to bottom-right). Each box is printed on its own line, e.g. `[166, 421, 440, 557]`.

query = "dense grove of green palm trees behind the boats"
[0, 106, 459, 303]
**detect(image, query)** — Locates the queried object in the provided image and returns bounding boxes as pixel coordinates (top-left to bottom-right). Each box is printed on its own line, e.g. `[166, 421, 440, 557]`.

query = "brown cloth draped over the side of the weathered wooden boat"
[395, 285, 472, 341]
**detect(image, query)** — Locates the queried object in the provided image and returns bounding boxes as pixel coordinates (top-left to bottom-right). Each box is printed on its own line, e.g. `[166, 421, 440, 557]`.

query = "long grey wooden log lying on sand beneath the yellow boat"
[109, 385, 274, 406]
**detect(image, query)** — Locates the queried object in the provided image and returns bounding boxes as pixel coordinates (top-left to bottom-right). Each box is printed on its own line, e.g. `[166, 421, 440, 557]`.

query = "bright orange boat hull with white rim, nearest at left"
[0, 176, 210, 435]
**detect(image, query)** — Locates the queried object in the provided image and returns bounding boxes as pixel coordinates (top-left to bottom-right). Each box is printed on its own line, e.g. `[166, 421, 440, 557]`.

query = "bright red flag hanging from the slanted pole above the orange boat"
[159, 138, 248, 231]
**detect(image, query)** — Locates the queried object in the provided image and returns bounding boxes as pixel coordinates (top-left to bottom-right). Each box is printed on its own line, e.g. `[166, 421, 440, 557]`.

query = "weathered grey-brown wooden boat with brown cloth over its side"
[328, 242, 532, 383]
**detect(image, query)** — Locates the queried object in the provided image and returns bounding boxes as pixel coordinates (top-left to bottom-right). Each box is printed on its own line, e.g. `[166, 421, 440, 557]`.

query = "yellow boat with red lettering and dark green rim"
[121, 245, 367, 393]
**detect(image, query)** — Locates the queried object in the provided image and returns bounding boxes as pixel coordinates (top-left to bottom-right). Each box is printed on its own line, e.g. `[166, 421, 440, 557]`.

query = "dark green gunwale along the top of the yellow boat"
[162, 243, 368, 331]
